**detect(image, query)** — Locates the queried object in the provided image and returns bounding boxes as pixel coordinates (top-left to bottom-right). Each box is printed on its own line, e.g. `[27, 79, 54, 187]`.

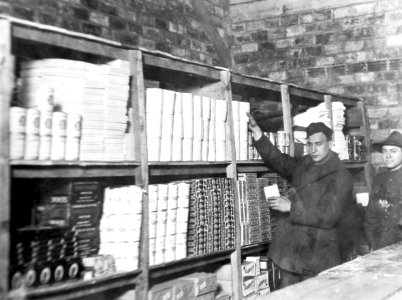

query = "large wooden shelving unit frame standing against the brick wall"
[0, 18, 371, 300]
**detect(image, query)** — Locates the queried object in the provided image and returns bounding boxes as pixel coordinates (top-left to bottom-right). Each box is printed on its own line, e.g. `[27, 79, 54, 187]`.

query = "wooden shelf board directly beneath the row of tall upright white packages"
[149, 161, 231, 176]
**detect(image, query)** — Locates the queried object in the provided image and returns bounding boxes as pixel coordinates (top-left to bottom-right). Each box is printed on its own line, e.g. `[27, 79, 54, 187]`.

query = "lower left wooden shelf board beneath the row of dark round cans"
[8, 270, 140, 300]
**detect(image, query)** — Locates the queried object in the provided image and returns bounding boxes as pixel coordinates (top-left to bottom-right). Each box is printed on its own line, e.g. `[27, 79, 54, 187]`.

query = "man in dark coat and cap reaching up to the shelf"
[248, 114, 352, 288]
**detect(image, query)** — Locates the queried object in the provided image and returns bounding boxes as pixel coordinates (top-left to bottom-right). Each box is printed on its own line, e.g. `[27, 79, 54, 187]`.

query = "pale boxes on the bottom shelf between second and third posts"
[148, 273, 217, 300]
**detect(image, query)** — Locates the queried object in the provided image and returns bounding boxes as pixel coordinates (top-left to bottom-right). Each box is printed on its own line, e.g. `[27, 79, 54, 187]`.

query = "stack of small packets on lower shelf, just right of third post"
[237, 173, 261, 245]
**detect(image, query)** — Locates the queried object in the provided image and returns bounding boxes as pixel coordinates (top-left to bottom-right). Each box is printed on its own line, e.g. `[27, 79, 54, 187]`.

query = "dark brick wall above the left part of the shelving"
[0, 0, 229, 66]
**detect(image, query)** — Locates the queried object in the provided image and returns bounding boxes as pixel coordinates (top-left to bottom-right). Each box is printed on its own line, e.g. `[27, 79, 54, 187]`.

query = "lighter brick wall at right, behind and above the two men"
[231, 0, 402, 155]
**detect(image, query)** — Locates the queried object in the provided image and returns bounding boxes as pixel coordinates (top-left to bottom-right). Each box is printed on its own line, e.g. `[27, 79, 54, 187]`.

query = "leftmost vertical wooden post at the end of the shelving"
[0, 20, 14, 299]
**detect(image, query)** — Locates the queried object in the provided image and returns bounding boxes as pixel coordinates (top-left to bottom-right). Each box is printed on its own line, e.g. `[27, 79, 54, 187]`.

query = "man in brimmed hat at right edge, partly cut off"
[366, 131, 402, 250]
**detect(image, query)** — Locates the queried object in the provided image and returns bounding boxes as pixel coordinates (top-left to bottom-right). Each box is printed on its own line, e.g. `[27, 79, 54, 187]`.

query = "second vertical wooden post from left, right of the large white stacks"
[129, 50, 149, 299]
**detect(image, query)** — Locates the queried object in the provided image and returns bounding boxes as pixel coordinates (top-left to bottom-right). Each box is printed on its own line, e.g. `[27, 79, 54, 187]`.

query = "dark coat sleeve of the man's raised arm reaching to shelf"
[254, 135, 297, 180]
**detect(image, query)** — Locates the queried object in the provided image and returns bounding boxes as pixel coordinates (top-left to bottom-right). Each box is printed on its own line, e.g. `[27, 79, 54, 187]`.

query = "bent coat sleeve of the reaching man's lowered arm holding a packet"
[290, 170, 352, 229]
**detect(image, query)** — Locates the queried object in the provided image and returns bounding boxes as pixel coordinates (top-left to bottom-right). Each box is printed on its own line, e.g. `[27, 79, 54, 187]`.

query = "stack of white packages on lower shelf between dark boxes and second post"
[99, 185, 142, 271]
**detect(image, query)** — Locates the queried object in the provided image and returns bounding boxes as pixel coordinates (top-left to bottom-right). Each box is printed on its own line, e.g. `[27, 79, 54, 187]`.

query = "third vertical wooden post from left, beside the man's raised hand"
[221, 71, 243, 300]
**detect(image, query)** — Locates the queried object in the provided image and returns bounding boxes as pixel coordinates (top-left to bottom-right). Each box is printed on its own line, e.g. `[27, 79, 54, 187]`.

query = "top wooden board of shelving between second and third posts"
[143, 52, 220, 81]
